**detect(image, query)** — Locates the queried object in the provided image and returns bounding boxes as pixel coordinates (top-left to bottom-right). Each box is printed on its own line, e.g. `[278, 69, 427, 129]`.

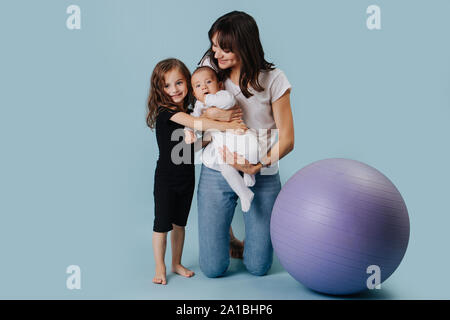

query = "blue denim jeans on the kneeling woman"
[197, 165, 281, 278]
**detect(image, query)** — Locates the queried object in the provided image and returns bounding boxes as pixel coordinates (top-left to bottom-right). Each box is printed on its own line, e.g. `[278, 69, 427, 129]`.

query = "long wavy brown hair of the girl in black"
[147, 58, 193, 129]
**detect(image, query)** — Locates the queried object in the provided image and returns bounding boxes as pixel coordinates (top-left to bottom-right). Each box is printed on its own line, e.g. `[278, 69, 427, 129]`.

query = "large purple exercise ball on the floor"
[270, 159, 409, 295]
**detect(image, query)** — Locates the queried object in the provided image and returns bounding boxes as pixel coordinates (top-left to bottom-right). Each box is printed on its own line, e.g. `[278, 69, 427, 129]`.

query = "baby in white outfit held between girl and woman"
[184, 66, 259, 212]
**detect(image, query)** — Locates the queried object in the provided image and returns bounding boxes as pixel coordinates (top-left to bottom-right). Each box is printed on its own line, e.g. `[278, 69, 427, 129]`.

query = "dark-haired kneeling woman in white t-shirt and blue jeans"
[197, 11, 294, 277]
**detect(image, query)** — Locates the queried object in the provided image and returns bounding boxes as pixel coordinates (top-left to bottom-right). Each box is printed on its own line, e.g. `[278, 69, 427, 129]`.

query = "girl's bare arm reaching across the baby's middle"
[170, 112, 248, 131]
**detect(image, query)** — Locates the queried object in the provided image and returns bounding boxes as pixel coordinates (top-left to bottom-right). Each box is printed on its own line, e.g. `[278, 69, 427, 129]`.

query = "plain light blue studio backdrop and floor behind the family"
[0, 0, 450, 299]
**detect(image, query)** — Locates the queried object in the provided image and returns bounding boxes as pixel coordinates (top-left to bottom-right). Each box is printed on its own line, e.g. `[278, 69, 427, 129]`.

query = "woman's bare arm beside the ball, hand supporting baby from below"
[219, 89, 294, 174]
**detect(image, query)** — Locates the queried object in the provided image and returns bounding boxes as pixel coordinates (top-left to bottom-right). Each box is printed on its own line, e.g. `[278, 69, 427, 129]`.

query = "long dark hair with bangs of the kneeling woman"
[202, 11, 275, 98]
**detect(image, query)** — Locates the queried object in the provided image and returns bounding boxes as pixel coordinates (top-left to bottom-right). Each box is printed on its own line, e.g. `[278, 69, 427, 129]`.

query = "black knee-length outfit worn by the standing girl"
[153, 107, 195, 232]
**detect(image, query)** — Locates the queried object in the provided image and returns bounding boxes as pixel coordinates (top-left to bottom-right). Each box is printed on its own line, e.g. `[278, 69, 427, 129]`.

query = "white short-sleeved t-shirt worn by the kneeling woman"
[202, 60, 291, 174]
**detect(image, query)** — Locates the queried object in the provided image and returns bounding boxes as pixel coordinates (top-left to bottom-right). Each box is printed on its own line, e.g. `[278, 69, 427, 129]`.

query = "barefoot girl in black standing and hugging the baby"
[147, 58, 247, 284]
